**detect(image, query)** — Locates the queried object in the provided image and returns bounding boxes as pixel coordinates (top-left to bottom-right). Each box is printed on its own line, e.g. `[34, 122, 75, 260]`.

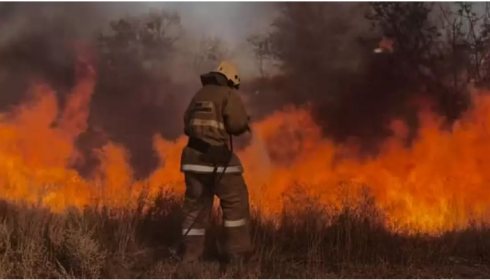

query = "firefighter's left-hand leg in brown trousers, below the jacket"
[182, 173, 213, 262]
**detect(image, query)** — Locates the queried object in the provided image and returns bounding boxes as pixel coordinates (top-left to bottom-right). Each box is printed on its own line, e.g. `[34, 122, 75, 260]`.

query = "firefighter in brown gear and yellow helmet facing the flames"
[177, 61, 252, 270]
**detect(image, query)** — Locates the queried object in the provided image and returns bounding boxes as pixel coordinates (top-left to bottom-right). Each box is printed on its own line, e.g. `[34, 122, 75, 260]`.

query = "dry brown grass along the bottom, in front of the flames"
[0, 190, 490, 278]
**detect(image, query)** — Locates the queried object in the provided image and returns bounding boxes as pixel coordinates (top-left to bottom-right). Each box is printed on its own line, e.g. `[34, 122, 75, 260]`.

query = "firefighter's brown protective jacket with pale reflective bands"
[181, 72, 249, 173]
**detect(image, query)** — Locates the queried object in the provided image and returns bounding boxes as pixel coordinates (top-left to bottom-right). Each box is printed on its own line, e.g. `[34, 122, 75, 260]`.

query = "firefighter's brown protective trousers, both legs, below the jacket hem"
[182, 172, 252, 262]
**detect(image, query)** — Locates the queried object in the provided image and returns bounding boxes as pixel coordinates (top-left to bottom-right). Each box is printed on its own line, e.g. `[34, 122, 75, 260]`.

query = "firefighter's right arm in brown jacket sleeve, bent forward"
[223, 90, 250, 135]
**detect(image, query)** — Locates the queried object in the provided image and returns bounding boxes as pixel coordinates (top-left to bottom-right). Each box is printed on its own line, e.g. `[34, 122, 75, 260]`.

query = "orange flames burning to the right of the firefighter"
[238, 101, 490, 233]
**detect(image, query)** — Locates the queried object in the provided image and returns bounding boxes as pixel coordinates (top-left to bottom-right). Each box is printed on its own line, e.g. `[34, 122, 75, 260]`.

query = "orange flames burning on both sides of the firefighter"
[0, 52, 490, 233]
